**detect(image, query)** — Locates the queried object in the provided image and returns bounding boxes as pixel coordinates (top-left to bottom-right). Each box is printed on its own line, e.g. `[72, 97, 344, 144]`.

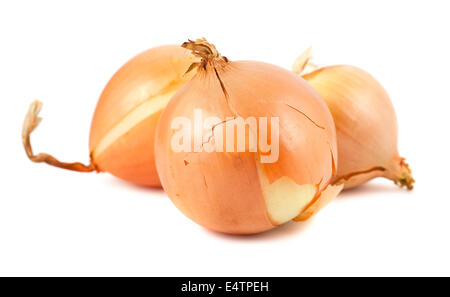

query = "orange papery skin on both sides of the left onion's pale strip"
[89, 45, 196, 186]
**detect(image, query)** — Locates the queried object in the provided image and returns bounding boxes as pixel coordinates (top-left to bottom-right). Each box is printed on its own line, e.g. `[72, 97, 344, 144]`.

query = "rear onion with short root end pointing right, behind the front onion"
[293, 49, 414, 190]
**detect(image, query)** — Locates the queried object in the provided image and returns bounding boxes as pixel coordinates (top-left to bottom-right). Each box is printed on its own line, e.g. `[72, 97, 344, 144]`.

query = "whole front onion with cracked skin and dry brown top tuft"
[155, 39, 342, 234]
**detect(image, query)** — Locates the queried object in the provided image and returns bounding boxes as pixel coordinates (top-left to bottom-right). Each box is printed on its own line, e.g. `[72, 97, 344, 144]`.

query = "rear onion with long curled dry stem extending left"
[22, 45, 197, 186]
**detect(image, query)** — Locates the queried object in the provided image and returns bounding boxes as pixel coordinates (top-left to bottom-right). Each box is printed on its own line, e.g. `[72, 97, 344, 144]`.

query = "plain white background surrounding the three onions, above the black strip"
[0, 0, 450, 276]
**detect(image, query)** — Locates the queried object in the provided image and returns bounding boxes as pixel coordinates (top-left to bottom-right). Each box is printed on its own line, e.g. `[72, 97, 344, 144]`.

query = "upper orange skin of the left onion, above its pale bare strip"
[89, 45, 195, 151]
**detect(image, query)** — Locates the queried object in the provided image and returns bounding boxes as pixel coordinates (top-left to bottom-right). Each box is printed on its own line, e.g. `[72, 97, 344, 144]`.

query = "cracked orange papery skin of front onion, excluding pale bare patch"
[155, 40, 337, 234]
